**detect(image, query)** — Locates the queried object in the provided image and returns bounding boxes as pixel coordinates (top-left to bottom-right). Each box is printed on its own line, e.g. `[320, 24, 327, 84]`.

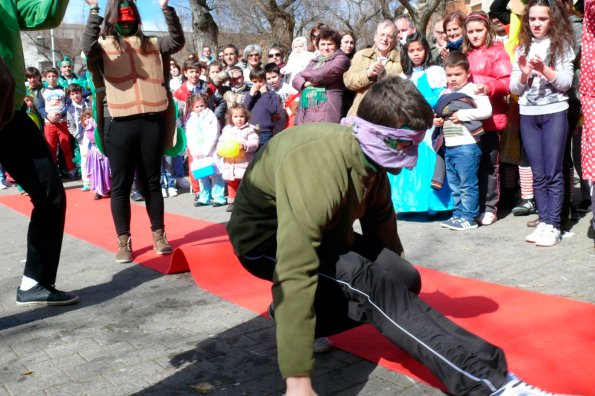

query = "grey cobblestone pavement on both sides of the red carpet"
[0, 182, 595, 396]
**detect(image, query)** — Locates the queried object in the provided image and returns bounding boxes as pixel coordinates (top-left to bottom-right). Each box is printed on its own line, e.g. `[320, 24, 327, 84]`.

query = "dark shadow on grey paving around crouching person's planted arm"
[135, 316, 376, 396]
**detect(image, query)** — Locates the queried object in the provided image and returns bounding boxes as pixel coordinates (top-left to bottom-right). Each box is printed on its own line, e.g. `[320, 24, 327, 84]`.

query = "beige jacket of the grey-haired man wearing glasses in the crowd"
[343, 46, 403, 116]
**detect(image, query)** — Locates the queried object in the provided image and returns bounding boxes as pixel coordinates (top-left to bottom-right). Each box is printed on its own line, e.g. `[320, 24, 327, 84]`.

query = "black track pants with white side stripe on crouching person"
[239, 235, 508, 395]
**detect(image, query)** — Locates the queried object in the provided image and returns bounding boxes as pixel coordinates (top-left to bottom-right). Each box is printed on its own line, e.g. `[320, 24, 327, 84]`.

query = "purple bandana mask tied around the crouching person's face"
[341, 116, 426, 170]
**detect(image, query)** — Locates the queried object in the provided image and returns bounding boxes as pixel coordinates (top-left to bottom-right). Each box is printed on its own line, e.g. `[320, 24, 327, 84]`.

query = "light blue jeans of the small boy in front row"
[445, 143, 481, 220]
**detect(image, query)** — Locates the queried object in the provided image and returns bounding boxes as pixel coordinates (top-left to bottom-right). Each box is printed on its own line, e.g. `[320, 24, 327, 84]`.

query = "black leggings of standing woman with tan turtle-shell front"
[105, 114, 164, 236]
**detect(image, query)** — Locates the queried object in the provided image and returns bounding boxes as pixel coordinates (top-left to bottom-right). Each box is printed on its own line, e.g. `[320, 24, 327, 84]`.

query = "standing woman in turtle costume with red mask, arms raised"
[82, 0, 184, 263]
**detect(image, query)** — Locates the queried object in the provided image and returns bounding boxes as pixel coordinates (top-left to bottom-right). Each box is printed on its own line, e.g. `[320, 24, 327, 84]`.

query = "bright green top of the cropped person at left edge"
[0, 0, 68, 110]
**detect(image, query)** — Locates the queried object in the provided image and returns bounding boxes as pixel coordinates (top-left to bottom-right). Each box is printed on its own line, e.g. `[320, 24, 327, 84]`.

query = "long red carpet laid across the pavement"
[0, 190, 595, 395]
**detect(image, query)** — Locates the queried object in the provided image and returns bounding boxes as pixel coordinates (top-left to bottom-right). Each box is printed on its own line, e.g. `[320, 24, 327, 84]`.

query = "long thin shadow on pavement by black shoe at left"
[0, 265, 162, 330]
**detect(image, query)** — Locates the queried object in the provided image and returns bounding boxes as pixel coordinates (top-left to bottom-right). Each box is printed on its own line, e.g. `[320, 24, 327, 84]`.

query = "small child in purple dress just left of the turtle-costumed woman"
[81, 109, 112, 199]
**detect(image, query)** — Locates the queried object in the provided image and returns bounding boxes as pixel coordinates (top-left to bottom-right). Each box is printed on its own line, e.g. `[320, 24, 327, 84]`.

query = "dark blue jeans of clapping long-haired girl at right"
[521, 110, 568, 229]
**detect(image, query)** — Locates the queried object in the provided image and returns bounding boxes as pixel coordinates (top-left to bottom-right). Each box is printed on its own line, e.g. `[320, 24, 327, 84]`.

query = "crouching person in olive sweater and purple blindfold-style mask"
[227, 77, 560, 396]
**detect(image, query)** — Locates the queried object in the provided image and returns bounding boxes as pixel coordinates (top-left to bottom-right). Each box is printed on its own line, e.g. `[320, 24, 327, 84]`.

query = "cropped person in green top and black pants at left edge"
[0, 0, 79, 305]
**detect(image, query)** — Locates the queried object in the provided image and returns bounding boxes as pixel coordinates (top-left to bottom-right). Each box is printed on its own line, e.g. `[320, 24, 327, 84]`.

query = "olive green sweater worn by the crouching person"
[227, 123, 402, 377]
